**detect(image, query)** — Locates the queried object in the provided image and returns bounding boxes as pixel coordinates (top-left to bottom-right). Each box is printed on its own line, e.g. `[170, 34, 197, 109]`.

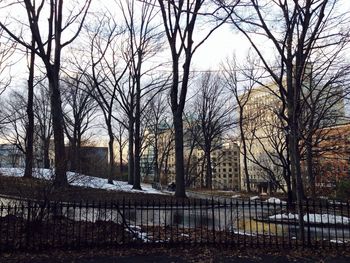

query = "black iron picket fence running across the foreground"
[0, 199, 350, 251]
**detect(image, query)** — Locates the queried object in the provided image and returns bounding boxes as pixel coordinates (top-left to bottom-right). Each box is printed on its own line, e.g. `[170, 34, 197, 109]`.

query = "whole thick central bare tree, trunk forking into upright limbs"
[158, 0, 235, 197]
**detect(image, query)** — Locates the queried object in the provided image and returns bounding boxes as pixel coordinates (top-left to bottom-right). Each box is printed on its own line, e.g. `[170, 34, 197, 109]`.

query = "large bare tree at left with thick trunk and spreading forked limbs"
[0, 0, 91, 187]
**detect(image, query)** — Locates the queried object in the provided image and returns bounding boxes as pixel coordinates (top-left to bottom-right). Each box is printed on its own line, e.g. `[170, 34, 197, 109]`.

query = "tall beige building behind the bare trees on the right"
[241, 79, 345, 192]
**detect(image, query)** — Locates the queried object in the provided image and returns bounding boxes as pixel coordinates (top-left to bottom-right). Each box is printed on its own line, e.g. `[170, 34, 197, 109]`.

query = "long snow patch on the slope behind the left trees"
[0, 168, 164, 194]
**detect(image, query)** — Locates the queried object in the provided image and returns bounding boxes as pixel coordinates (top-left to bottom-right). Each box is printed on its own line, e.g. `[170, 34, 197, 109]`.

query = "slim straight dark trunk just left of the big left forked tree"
[24, 39, 35, 178]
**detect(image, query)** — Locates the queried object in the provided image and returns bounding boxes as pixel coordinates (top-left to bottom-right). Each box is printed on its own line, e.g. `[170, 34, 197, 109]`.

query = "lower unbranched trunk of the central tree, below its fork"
[173, 111, 186, 197]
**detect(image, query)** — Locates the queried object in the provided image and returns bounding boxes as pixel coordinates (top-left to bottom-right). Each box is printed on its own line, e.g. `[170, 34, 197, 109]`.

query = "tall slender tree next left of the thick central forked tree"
[120, 0, 162, 189]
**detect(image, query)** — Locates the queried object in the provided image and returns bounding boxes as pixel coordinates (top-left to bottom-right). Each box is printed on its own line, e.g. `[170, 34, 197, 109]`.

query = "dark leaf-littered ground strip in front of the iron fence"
[0, 246, 350, 263]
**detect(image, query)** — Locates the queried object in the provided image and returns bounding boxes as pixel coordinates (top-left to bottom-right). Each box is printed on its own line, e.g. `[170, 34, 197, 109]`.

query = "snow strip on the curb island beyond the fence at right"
[269, 213, 350, 225]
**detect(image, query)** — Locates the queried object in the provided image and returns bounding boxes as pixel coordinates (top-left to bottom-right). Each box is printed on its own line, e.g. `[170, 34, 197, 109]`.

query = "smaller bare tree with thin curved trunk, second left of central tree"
[80, 14, 130, 184]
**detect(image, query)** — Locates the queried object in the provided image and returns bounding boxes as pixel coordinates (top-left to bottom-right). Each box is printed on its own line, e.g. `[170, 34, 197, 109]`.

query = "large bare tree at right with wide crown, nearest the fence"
[222, 0, 349, 240]
